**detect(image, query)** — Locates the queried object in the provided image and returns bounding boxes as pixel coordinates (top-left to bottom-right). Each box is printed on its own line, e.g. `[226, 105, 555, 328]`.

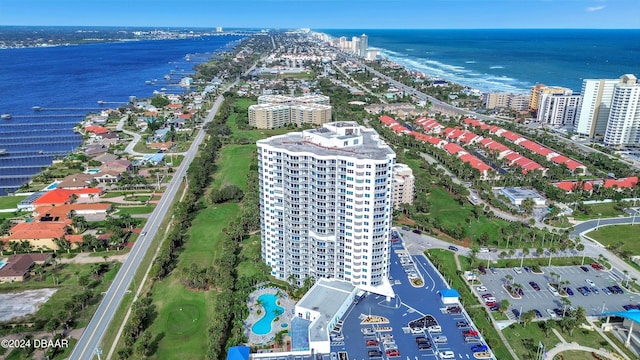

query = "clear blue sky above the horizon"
[0, 0, 640, 29]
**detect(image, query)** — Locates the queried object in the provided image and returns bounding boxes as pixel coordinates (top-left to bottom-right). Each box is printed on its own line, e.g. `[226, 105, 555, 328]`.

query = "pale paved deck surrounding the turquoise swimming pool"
[244, 287, 296, 345]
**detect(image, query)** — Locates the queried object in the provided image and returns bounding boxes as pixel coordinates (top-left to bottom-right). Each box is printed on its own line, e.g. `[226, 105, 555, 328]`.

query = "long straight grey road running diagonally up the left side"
[70, 96, 224, 360]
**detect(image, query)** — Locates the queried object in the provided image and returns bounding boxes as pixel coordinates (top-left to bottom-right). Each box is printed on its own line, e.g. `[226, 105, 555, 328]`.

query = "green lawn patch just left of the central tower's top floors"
[211, 145, 257, 190]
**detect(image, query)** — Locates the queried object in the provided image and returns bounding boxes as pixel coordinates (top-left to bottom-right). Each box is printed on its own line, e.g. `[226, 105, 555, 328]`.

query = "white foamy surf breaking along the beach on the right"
[382, 50, 532, 93]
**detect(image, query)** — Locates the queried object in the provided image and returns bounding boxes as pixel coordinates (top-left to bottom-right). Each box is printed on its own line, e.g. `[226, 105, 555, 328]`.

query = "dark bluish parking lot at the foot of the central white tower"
[331, 232, 492, 360]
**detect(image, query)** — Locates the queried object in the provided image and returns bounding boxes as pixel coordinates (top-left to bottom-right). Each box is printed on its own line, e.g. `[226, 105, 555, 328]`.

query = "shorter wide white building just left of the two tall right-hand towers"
[536, 94, 582, 128]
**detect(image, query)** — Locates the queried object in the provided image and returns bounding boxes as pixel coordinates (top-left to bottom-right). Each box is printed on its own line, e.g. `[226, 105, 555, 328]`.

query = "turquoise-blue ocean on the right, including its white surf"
[316, 29, 640, 92]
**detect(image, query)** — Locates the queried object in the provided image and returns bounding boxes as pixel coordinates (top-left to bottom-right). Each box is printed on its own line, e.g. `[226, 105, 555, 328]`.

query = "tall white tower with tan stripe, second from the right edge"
[574, 79, 620, 138]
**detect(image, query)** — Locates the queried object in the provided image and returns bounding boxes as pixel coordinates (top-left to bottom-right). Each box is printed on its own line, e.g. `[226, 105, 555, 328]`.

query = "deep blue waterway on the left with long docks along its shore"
[0, 35, 241, 196]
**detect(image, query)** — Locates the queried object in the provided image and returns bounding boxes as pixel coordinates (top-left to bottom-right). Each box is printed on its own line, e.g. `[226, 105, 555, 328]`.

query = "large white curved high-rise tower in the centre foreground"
[257, 122, 396, 296]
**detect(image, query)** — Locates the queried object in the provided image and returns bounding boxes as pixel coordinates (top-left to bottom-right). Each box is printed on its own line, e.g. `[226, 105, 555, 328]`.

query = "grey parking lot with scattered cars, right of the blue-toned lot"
[474, 264, 640, 320]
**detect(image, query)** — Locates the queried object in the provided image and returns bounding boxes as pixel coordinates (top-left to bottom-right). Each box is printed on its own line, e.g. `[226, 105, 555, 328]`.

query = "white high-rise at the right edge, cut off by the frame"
[604, 74, 640, 146]
